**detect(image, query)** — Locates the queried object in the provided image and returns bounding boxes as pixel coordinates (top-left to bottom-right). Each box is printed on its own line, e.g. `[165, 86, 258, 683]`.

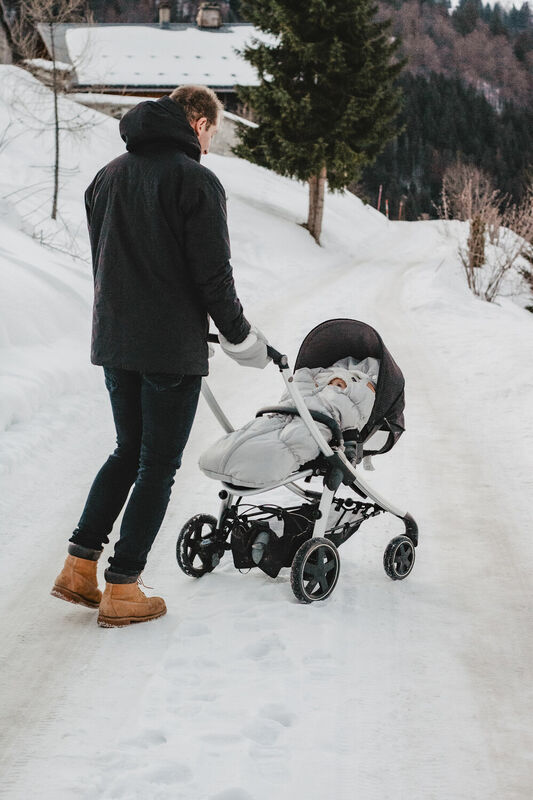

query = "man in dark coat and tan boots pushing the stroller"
[52, 86, 268, 627]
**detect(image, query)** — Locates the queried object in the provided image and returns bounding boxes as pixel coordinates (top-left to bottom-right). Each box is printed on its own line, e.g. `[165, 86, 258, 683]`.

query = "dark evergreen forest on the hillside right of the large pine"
[356, 72, 533, 220]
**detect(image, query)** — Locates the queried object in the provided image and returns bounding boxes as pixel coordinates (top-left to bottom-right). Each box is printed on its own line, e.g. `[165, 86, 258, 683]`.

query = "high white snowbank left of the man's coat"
[0, 66, 122, 468]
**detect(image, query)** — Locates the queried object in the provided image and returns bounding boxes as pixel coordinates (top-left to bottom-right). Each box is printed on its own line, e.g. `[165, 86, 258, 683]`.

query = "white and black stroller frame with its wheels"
[176, 326, 418, 603]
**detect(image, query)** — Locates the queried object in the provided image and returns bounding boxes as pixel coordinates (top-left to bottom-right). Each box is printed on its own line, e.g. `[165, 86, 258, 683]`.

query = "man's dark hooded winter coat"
[85, 97, 250, 375]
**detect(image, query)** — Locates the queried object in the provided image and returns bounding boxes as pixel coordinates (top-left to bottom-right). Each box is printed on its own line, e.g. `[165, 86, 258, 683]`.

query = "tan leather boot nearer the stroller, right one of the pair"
[98, 578, 167, 628]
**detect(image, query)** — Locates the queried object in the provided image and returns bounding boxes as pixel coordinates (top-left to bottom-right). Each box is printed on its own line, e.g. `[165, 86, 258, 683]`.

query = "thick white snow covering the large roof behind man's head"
[65, 24, 273, 88]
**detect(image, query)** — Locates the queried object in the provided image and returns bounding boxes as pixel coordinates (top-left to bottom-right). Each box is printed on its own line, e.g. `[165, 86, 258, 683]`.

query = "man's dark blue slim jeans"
[70, 367, 202, 575]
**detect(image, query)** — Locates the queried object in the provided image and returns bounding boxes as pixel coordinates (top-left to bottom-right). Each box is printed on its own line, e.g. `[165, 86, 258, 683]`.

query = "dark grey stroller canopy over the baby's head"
[294, 318, 405, 455]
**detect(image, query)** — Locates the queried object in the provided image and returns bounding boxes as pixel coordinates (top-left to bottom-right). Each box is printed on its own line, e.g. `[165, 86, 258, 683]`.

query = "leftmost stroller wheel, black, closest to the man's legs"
[176, 514, 225, 578]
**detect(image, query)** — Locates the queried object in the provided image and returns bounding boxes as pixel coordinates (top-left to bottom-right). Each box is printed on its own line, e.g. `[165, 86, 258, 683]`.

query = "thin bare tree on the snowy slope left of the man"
[12, 0, 90, 219]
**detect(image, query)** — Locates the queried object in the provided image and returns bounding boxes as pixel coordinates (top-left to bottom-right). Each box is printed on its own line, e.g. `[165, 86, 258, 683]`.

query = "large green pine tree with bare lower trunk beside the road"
[236, 0, 403, 242]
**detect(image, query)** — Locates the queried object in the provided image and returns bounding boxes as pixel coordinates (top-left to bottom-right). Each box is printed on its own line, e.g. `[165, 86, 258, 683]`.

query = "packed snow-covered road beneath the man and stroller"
[0, 211, 533, 800]
